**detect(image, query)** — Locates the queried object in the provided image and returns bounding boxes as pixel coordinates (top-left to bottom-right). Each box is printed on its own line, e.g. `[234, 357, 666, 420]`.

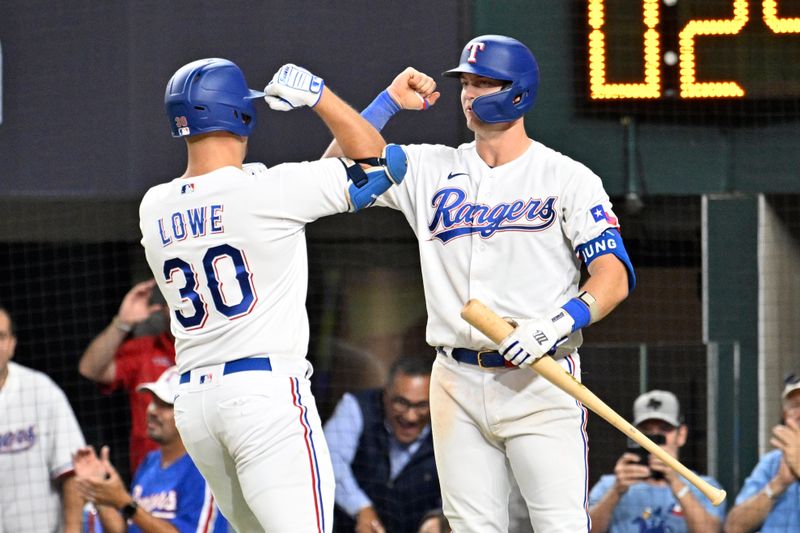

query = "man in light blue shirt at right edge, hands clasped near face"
[725, 374, 800, 533]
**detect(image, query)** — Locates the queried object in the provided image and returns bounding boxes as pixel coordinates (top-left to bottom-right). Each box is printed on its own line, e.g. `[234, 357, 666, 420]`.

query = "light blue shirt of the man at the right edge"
[736, 450, 800, 533]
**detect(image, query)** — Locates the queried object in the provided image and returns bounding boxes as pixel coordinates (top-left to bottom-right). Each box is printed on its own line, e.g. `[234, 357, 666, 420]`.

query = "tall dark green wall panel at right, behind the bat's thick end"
[704, 194, 758, 494]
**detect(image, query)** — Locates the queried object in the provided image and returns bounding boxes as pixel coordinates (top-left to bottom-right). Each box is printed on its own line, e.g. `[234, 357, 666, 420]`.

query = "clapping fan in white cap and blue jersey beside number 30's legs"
[73, 366, 228, 533]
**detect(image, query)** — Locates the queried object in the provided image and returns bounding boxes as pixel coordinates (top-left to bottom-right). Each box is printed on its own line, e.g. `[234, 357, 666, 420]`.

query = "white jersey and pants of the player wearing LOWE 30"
[139, 159, 349, 533]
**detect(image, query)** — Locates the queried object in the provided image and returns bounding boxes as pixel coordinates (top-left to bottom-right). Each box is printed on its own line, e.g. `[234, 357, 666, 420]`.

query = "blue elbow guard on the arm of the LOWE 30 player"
[342, 144, 408, 212]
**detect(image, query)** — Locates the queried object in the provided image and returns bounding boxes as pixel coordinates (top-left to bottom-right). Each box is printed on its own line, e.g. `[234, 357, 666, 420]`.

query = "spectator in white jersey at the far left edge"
[0, 307, 84, 533]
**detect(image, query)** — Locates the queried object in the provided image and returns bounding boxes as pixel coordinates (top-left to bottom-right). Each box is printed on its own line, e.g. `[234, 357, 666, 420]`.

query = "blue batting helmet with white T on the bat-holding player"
[444, 35, 539, 124]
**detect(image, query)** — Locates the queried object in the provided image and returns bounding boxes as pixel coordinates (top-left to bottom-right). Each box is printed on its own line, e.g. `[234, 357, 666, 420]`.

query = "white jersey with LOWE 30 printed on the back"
[139, 159, 349, 373]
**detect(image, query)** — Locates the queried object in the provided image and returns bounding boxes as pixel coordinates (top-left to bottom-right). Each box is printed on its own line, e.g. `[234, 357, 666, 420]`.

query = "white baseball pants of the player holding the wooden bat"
[430, 354, 589, 533]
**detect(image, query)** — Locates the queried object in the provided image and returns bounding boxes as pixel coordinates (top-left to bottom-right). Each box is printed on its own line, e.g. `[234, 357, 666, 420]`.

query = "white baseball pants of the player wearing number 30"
[175, 358, 335, 533]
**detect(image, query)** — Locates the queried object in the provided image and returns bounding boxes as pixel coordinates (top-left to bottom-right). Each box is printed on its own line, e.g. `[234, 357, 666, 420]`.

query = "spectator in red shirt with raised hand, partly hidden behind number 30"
[78, 280, 175, 472]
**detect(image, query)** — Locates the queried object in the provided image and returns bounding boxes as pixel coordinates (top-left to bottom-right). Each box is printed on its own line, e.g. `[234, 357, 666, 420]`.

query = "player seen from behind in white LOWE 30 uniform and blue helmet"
[140, 58, 406, 533]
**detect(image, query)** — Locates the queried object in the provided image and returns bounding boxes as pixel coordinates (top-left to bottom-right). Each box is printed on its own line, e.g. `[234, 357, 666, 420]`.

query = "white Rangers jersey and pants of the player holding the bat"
[378, 141, 617, 533]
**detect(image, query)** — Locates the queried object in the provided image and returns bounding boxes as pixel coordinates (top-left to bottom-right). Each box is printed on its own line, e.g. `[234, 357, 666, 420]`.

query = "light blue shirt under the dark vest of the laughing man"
[324, 393, 431, 518]
